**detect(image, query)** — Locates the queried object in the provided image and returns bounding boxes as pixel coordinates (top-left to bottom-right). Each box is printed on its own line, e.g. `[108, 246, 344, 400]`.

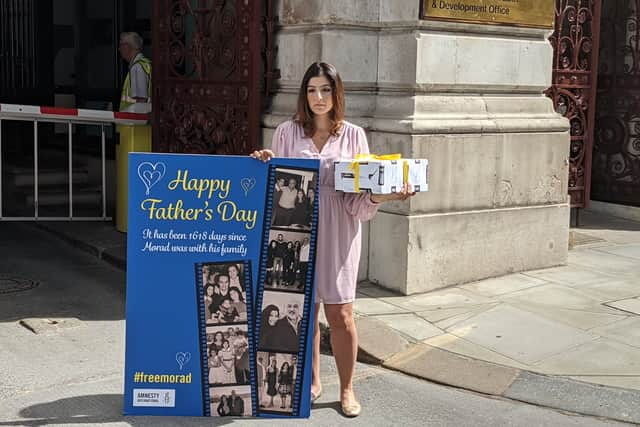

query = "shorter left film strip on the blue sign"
[195, 260, 256, 417]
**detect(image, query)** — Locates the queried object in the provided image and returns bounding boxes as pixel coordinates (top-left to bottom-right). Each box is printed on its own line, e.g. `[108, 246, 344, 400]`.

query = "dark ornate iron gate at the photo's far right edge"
[592, 0, 640, 206]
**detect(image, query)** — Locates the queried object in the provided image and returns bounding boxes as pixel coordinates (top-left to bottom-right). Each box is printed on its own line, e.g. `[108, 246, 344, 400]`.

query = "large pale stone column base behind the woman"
[265, 0, 569, 294]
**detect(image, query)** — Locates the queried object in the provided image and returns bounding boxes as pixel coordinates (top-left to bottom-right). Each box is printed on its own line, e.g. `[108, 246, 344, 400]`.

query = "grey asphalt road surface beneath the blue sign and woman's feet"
[0, 222, 623, 427]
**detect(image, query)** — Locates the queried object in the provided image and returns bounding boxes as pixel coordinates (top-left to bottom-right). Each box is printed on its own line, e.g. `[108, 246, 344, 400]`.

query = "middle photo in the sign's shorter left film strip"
[207, 325, 251, 385]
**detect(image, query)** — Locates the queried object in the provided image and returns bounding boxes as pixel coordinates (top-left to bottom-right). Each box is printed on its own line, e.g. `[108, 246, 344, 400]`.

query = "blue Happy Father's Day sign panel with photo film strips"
[124, 153, 319, 417]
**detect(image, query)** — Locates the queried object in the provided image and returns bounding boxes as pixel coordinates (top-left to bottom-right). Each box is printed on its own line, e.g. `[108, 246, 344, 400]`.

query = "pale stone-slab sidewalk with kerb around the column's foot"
[27, 208, 640, 423]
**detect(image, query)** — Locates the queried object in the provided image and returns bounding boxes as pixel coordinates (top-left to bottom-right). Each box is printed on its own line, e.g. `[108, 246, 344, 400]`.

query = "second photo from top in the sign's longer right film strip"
[264, 229, 311, 292]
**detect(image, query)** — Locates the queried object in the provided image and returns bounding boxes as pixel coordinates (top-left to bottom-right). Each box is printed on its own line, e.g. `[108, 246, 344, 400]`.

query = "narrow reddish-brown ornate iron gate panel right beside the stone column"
[547, 0, 601, 208]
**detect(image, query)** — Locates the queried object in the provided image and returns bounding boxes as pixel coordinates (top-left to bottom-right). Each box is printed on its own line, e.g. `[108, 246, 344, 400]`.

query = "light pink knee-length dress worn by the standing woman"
[272, 120, 378, 304]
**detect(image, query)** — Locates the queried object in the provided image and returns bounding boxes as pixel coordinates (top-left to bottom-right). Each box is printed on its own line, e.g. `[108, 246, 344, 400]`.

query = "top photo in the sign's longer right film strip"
[271, 168, 317, 231]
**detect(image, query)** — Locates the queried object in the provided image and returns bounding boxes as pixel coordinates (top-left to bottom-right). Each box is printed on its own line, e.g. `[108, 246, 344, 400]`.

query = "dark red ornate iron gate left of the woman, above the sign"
[153, 0, 271, 154]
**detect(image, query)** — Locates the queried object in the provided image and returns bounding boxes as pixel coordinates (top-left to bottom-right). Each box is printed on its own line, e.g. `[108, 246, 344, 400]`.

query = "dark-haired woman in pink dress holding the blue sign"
[251, 62, 412, 417]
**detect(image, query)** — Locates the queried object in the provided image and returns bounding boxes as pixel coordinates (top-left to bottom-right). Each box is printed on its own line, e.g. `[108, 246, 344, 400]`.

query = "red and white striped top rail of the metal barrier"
[0, 104, 149, 125]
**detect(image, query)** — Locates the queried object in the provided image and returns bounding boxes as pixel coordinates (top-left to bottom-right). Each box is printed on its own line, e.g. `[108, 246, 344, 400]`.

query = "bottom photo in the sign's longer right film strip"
[256, 351, 298, 413]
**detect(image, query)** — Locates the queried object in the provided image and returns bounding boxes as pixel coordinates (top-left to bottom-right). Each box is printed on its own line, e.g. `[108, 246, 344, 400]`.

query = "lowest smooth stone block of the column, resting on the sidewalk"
[369, 204, 569, 294]
